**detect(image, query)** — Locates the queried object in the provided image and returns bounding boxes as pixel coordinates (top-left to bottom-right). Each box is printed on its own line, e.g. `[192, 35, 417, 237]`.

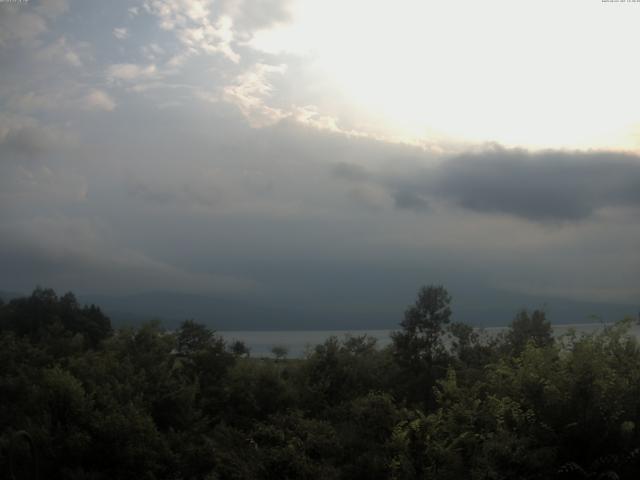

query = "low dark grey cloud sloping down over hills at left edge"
[0, 216, 256, 293]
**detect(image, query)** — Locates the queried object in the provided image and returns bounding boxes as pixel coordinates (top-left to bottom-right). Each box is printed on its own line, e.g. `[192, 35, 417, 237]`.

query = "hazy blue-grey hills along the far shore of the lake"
[0, 289, 640, 330]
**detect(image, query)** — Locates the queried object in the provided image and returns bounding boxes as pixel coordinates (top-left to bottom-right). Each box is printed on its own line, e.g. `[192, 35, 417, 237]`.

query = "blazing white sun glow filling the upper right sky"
[253, 0, 640, 150]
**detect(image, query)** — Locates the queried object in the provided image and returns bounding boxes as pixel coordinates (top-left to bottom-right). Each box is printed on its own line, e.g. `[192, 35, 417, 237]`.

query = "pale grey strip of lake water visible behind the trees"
[218, 323, 640, 358]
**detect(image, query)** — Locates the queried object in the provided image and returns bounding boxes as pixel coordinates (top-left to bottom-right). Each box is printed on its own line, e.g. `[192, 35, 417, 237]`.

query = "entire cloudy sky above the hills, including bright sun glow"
[0, 0, 640, 326]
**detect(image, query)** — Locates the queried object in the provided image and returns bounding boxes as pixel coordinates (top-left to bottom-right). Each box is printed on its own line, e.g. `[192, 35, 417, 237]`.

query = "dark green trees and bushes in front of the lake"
[0, 286, 640, 480]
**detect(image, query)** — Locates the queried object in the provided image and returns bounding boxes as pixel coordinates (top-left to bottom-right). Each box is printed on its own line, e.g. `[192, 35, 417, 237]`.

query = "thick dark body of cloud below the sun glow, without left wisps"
[425, 147, 640, 222]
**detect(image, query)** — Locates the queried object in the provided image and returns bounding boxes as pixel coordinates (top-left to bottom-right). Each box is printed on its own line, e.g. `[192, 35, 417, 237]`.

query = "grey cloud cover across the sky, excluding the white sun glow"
[0, 0, 640, 312]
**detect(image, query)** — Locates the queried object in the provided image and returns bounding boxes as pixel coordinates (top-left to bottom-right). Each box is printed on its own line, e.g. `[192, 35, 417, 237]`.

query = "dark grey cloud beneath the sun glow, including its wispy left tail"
[338, 146, 640, 223]
